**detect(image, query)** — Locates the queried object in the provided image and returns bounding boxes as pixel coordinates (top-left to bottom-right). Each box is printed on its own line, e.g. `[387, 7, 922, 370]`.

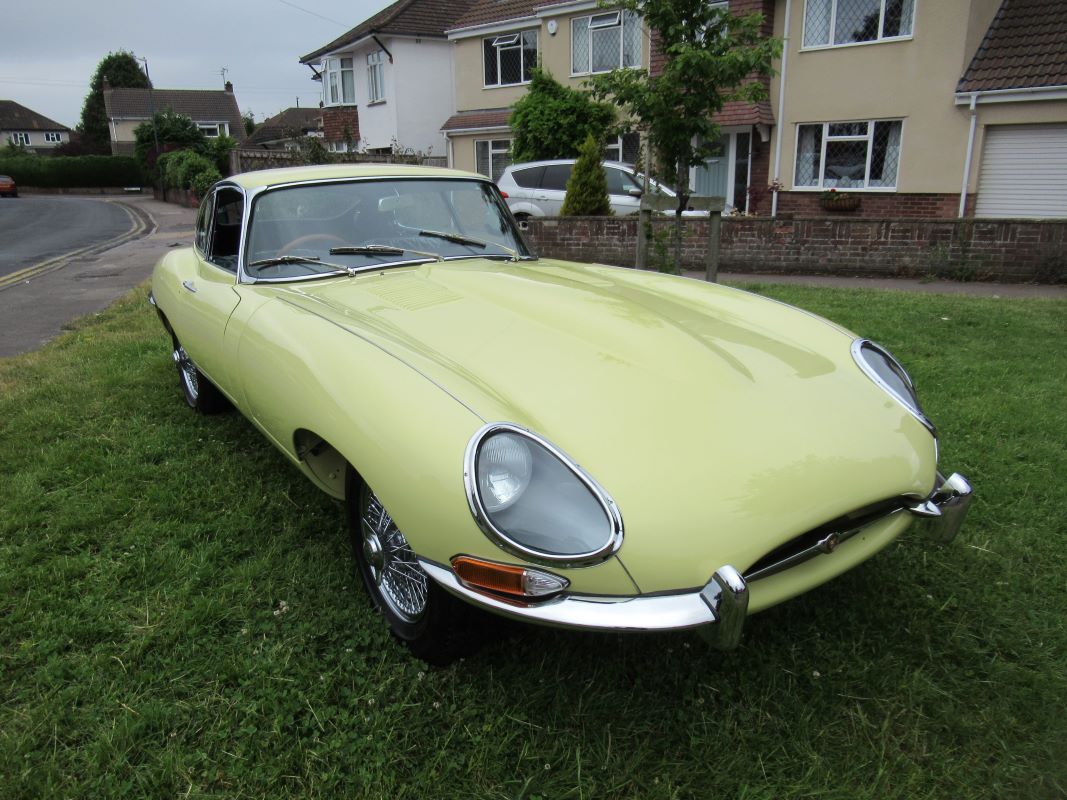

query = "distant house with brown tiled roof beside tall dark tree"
[103, 79, 245, 156]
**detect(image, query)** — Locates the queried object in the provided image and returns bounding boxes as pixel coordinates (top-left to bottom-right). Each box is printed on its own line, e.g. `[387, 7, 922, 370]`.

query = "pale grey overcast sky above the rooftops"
[0, 0, 391, 128]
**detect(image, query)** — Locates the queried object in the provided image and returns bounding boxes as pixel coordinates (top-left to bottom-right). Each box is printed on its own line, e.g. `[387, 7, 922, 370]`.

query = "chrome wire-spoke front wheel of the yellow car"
[360, 485, 427, 623]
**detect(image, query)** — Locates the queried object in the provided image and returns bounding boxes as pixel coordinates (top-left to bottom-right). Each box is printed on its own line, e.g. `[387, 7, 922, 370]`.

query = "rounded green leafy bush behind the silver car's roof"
[508, 69, 616, 161]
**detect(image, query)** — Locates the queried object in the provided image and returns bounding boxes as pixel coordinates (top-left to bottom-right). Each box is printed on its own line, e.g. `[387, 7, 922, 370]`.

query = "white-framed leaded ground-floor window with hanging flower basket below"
[793, 119, 903, 189]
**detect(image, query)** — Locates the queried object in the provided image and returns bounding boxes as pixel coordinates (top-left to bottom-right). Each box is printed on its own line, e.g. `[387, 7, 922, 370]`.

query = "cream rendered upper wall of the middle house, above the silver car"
[452, 7, 650, 111]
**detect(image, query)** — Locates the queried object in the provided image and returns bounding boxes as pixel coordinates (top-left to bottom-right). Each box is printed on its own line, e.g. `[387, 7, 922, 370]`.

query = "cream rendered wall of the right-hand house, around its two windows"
[771, 0, 999, 193]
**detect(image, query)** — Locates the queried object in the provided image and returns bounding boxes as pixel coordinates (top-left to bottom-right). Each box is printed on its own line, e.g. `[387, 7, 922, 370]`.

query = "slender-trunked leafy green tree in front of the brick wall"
[590, 0, 782, 269]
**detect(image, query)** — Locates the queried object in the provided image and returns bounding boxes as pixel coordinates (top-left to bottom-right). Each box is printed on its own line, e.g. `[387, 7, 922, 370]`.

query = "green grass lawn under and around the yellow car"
[0, 286, 1067, 800]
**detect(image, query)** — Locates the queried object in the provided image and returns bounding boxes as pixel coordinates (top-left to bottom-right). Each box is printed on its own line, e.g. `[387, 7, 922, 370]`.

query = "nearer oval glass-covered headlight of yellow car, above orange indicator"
[464, 422, 622, 565]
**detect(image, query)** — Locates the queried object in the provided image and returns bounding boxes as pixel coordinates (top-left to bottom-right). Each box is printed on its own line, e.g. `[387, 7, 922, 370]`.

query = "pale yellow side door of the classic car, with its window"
[172, 187, 244, 397]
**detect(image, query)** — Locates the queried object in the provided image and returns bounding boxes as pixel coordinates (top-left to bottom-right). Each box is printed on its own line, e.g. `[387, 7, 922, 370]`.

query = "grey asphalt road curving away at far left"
[0, 195, 133, 277]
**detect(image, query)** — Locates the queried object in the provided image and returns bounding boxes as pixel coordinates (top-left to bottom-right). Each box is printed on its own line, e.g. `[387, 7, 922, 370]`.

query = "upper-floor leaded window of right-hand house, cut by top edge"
[803, 0, 915, 47]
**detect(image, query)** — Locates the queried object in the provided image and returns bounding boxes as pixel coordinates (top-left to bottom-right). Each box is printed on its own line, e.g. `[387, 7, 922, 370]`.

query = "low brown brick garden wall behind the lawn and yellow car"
[525, 215, 1067, 284]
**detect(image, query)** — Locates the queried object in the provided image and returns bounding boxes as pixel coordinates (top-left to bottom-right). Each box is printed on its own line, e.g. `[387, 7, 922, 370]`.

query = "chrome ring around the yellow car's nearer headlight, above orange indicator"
[463, 422, 623, 567]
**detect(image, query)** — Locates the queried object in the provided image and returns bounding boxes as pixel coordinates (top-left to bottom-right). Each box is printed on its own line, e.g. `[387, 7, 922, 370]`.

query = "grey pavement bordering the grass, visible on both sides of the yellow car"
[0, 196, 1067, 357]
